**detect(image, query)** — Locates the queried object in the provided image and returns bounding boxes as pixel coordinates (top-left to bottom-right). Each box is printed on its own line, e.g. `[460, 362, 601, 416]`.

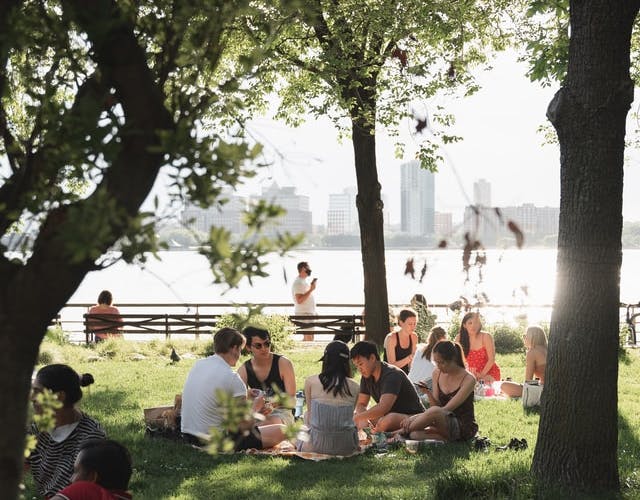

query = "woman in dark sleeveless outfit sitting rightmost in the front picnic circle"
[401, 340, 478, 441]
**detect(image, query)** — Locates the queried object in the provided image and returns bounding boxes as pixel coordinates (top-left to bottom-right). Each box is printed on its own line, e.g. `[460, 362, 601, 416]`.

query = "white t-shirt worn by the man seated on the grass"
[182, 354, 247, 437]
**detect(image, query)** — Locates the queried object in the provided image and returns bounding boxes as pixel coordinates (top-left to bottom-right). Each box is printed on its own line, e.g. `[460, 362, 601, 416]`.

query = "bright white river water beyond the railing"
[69, 249, 640, 305]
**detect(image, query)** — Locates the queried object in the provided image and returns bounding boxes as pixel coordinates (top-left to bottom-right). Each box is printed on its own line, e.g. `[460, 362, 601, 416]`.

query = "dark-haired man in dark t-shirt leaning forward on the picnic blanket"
[351, 341, 425, 432]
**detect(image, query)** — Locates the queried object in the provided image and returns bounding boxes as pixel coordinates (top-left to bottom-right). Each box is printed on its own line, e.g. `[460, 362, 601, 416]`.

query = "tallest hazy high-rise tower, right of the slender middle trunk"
[400, 160, 435, 236]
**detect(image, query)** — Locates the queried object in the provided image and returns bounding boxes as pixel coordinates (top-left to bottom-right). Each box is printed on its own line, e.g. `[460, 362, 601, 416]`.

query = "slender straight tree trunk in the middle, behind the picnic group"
[351, 114, 389, 346]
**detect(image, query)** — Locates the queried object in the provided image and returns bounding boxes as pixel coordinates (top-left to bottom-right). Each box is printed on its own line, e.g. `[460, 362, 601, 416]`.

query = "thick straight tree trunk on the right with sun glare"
[532, 0, 638, 491]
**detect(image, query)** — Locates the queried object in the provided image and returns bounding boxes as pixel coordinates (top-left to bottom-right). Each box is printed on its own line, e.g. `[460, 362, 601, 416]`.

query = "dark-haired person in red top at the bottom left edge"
[51, 439, 132, 500]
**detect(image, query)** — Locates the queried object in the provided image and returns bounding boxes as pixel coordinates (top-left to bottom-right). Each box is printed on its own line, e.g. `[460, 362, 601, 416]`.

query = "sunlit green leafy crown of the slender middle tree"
[246, 0, 513, 170]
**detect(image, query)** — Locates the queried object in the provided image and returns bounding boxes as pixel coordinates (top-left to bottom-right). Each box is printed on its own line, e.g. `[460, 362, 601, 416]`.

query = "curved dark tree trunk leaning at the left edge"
[0, 0, 174, 498]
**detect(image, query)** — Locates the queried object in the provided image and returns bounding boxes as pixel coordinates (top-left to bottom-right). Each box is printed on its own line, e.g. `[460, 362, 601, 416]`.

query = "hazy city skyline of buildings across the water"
[182, 177, 560, 246]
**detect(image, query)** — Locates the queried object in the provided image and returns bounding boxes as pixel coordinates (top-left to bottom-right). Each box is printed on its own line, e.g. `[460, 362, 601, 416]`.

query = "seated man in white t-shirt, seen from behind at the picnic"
[181, 328, 285, 451]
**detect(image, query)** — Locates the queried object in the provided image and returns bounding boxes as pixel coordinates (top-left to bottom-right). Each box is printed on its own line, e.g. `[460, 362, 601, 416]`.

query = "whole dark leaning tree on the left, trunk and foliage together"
[0, 0, 297, 497]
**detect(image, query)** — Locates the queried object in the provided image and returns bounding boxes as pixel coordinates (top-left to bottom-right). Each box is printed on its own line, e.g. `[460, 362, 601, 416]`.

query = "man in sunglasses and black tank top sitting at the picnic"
[238, 326, 296, 426]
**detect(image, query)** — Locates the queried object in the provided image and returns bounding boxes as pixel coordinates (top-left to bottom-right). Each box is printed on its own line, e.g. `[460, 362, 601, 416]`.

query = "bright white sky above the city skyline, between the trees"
[228, 53, 640, 224]
